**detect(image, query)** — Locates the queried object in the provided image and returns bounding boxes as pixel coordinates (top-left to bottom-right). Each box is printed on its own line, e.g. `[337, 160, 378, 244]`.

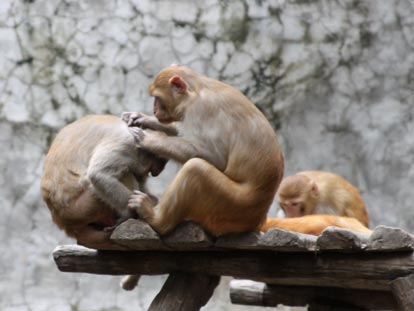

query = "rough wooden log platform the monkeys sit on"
[53, 219, 414, 311]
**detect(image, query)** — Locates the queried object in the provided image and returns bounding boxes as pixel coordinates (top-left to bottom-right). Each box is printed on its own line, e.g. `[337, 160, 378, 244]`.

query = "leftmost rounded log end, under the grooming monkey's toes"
[111, 219, 166, 250]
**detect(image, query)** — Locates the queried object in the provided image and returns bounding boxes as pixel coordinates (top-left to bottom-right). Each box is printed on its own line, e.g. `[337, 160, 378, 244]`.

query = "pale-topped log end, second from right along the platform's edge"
[316, 227, 370, 251]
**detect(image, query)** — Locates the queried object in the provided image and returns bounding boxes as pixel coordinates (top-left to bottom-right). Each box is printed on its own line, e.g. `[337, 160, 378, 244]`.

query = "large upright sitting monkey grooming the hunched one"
[129, 65, 283, 235]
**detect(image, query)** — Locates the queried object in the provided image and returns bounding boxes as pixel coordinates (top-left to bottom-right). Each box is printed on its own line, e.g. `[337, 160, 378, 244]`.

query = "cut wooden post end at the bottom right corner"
[391, 274, 414, 311]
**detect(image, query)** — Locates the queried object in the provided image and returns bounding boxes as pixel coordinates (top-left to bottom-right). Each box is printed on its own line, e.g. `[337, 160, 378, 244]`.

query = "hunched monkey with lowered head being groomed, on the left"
[42, 115, 166, 249]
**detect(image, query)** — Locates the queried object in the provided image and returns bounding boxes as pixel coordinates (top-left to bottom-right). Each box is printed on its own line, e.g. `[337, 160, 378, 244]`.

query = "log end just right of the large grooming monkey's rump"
[258, 229, 317, 252]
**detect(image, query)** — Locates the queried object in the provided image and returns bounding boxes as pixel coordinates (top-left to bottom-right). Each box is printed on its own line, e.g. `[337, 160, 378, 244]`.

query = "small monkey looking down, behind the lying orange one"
[277, 171, 369, 227]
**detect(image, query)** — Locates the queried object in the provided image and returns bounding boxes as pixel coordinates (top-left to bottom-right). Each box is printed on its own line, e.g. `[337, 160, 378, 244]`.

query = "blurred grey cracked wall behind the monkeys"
[0, 0, 414, 311]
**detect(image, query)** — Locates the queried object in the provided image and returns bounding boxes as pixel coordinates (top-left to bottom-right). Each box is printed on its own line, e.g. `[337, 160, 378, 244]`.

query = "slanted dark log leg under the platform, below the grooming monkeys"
[148, 273, 220, 311]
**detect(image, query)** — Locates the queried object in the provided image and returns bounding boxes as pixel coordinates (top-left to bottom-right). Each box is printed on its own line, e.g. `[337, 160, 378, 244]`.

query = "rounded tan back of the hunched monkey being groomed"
[42, 115, 133, 226]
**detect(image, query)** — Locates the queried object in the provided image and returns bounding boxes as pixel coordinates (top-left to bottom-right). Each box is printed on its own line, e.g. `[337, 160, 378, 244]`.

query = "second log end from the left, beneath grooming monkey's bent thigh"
[162, 221, 214, 250]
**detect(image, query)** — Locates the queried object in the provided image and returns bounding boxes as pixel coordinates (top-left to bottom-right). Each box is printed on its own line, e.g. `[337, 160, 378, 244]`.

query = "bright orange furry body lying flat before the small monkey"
[260, 215, 372, 235]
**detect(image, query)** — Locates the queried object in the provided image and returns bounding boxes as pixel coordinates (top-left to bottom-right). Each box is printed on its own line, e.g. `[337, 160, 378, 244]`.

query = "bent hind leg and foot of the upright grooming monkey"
[133, 158, 273, 235]
